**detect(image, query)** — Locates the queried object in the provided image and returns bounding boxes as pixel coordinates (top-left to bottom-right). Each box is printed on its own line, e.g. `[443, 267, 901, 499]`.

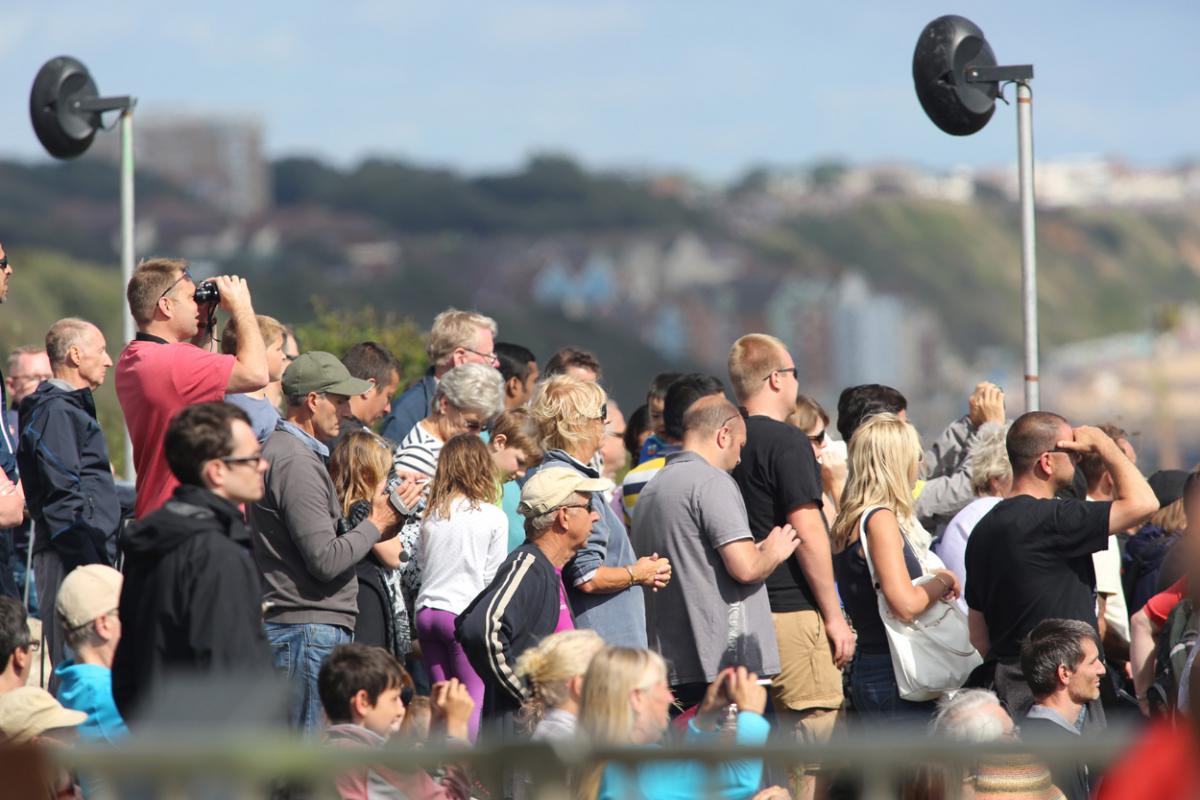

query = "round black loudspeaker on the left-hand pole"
[29, 55, 101, 158]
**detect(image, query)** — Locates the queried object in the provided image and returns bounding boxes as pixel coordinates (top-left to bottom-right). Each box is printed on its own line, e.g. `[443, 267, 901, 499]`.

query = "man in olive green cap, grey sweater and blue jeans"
[250, 351, 402, 730]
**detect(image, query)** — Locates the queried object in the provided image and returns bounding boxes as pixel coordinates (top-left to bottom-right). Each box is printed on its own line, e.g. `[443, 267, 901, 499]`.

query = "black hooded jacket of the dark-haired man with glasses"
[113, 485, 271, 722]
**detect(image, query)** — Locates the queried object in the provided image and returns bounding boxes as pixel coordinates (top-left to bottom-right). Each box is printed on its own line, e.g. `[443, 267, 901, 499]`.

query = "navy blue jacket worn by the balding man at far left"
[17, 380, 121, 573]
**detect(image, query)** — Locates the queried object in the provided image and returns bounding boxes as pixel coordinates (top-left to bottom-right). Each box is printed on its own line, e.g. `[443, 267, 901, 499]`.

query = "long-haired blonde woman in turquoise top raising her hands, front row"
[577, 648, 770, 800]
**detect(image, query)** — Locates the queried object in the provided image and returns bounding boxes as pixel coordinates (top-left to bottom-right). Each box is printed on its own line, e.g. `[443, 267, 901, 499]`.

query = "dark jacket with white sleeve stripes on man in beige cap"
[455, 542, 560, 716]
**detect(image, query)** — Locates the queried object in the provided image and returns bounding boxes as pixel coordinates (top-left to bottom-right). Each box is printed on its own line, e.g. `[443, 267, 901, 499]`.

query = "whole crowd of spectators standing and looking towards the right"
[0, 249, 1200, 800]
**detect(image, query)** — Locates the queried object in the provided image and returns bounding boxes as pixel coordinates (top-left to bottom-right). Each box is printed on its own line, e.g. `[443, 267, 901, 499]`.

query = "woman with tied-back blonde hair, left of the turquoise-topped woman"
[517, 628, 605, 741]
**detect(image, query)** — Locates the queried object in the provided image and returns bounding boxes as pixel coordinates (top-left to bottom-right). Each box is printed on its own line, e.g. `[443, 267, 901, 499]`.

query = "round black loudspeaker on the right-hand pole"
[912, 14, 1000, 136]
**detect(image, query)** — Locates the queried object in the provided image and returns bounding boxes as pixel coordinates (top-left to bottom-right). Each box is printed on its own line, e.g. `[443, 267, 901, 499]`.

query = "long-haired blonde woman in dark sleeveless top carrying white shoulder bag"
[832, 414, 961, 720]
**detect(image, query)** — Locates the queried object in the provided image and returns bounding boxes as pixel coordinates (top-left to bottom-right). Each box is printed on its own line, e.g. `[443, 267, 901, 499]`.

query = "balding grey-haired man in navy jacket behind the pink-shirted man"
[17, 317, 121, 664]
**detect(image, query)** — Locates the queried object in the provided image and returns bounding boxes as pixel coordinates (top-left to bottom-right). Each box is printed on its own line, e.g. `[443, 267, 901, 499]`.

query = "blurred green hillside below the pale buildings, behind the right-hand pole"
[769, 199, 1200, 349]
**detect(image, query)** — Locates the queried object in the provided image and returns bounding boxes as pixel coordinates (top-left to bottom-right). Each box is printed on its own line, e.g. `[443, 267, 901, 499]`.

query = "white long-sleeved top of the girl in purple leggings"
[415, 497, 509, 614]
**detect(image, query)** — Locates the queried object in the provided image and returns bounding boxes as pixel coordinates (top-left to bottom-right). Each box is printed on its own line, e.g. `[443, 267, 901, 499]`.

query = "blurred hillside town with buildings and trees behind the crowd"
[0, 1, 1200, 467]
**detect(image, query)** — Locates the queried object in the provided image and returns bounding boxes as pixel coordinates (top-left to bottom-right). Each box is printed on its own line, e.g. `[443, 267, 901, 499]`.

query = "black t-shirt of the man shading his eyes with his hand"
[966, 494, 1112, 661]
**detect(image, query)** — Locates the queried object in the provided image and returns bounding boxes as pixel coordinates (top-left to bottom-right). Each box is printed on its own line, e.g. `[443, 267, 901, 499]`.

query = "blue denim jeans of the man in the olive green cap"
[264, 622, 354, 733]
